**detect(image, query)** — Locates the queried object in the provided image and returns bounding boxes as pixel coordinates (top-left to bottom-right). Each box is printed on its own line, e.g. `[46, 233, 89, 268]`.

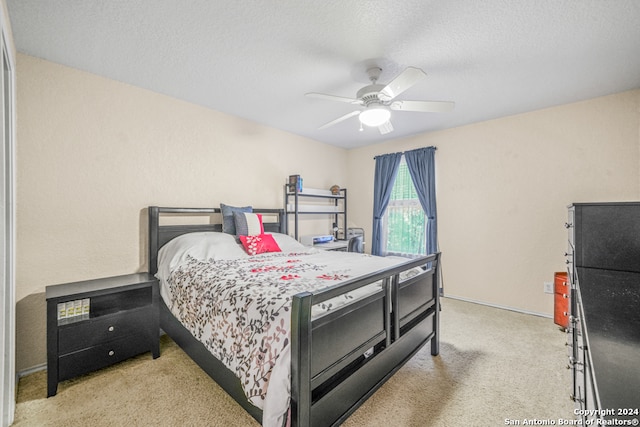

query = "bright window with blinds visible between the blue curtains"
[382, 159, 427, 257]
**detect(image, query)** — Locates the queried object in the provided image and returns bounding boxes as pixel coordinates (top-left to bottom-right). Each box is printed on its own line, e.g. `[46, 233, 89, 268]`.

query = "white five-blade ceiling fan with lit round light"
[306, 66, 455, 135]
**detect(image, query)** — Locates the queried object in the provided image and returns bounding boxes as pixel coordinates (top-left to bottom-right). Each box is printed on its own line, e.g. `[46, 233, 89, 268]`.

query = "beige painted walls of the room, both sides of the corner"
[16, 55, 640, 371]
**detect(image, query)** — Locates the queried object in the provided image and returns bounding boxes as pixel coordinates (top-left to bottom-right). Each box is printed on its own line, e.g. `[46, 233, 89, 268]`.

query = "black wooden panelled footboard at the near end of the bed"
[291, 253, 440, 427]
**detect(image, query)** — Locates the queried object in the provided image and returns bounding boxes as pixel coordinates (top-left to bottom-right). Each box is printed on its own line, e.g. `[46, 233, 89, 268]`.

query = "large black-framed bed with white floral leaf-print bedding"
[148, 206, 440, 427]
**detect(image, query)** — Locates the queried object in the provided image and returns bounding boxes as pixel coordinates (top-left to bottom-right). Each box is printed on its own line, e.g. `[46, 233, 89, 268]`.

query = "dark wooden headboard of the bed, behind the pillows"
[149, 206, 286, 274]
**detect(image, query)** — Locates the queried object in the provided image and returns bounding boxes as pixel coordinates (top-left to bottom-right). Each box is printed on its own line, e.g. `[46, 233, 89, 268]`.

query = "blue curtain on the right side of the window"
[404, 147, 438, 254]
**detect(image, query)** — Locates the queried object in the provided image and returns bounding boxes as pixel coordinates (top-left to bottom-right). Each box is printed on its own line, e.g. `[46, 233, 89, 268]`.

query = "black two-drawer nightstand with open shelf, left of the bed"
[46, 273, 160, 397]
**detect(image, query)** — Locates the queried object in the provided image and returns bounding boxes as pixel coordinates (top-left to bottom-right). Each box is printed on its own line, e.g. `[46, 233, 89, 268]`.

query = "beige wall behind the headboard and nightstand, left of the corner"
[16, 55, 346, 371]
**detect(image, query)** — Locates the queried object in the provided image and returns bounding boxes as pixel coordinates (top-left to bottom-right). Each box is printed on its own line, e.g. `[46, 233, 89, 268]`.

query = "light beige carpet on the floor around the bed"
[13, 298, 573, 427]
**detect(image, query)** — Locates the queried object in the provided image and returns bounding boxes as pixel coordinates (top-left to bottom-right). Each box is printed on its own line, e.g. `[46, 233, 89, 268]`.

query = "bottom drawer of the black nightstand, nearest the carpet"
[58, 335, 151, 381]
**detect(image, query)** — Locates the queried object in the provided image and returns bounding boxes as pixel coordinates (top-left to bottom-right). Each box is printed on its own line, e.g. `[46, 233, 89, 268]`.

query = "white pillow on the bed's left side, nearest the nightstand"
[156, 231, 248, 281]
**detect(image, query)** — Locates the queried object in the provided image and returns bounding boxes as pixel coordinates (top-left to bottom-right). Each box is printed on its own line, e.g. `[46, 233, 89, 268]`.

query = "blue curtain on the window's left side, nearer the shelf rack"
[371, 153, 402, 255]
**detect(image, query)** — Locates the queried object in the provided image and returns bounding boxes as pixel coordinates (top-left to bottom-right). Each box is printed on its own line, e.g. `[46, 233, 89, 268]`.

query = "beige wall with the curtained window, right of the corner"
[348, 91, 640, 315]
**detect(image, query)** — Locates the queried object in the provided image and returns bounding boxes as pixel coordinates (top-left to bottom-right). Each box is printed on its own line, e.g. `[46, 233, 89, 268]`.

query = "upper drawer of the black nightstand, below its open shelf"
[58, 306, 152, 355]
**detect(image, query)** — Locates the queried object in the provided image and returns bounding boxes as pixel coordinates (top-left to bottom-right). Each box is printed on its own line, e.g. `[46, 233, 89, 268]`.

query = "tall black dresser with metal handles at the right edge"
[567, 202, 640, 425]
